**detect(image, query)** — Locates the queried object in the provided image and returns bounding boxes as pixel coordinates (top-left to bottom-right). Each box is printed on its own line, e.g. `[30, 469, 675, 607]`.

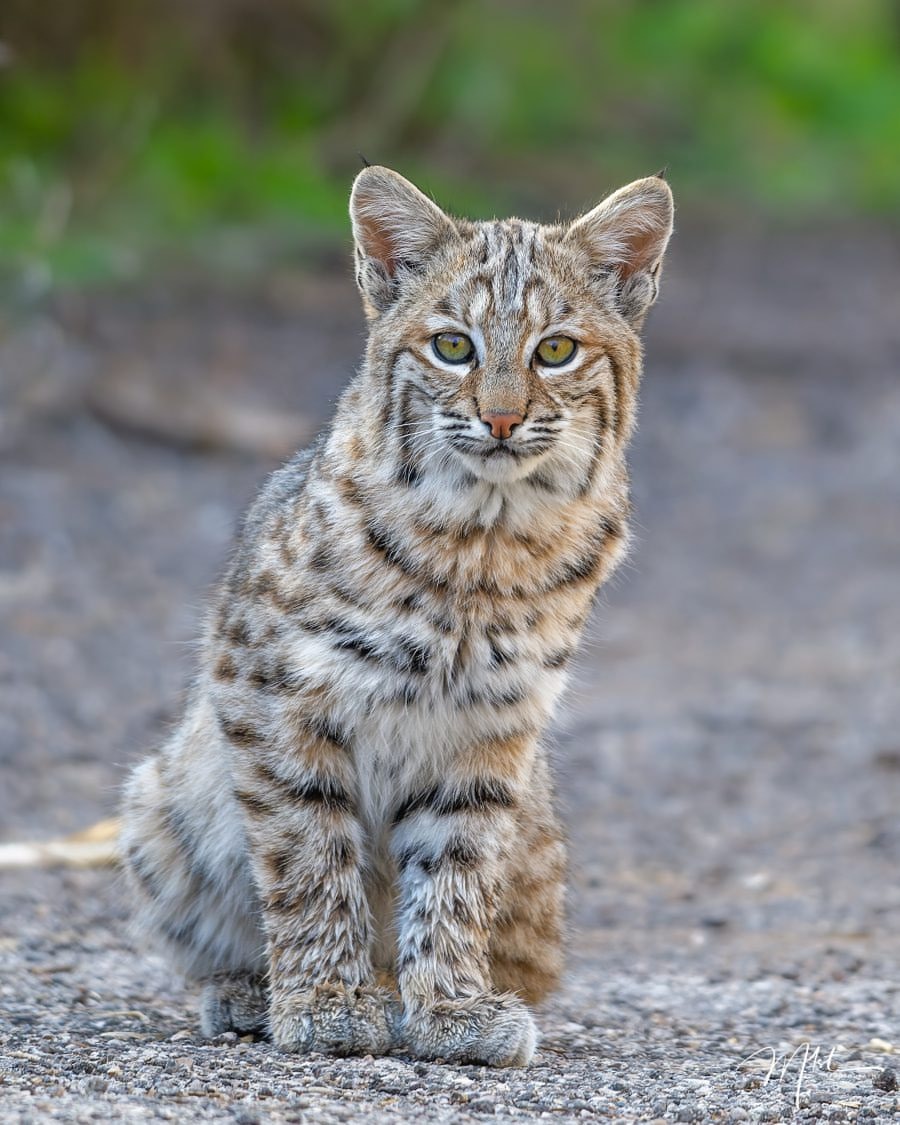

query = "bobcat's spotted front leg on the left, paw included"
[225, 711, 392, 1054]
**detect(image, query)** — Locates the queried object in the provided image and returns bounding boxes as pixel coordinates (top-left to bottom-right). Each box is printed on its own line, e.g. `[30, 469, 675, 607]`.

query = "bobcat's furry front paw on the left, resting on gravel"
[269, 984, 397, 1055]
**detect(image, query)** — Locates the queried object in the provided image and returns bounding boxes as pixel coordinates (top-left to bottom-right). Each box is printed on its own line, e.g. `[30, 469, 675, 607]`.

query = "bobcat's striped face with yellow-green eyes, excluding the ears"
[388, 223, 610, 482]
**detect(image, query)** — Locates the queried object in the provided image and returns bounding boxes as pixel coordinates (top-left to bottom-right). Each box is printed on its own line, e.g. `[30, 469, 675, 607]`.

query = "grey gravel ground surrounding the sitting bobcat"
[0, 217, 900, 1125]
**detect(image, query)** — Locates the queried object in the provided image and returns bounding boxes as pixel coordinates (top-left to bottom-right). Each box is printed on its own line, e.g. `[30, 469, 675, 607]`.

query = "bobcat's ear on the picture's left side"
[350, 165, 457, 315]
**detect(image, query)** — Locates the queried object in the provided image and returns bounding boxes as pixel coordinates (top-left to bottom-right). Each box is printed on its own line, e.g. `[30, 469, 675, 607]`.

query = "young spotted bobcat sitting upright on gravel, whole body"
[124, 168, 673, 1065]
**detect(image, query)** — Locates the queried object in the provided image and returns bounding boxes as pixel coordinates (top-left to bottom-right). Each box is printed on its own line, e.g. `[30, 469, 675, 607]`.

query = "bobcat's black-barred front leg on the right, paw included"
[392, 736, 538, 1067]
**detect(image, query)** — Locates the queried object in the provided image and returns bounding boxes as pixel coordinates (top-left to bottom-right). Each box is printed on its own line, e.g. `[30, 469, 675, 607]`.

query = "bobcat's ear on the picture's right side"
[567, 176, 675, 327]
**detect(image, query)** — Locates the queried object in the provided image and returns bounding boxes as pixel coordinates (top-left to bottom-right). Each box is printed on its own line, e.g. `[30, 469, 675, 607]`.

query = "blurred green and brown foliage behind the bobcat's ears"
[0, 0, 900, 289]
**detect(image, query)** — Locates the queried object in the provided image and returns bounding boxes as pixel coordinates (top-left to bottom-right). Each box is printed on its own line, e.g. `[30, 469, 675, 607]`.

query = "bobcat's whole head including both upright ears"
[351, 169, 672, 483]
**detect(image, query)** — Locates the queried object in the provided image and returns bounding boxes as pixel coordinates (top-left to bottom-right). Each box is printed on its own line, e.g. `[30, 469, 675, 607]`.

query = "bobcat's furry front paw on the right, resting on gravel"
[402, 995, 538, 1067]
